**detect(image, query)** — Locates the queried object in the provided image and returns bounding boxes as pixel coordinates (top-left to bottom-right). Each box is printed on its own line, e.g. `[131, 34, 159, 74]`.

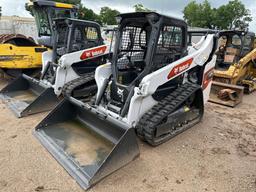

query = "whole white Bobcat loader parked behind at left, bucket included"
[0, 18, 109, 117]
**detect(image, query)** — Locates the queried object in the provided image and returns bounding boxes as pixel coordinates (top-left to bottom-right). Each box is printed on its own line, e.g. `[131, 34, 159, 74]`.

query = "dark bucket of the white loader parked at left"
[0, 74, 59, 118]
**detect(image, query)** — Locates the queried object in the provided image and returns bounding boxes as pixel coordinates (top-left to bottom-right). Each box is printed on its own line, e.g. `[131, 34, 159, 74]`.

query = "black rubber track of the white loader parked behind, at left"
[62, 73, 94, 97]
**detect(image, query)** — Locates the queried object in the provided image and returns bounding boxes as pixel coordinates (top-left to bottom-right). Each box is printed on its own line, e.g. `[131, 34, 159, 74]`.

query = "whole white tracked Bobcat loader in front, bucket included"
[34, 12, 217, 189]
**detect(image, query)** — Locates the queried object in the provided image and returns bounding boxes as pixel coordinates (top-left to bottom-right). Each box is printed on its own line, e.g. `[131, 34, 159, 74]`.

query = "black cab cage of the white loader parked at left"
[53, 18, 104, 62]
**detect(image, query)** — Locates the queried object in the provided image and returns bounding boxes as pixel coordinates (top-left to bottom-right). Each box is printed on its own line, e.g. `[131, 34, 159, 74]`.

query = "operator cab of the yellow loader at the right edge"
[216, 31, 255, 71]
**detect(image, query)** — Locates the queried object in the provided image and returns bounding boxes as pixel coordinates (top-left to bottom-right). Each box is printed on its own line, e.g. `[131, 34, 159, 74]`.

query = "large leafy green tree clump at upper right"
[183, 0, 252, 29]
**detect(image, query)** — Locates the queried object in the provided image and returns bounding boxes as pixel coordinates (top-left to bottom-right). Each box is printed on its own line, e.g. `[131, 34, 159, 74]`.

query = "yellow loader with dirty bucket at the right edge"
[209, 30, 256, 107]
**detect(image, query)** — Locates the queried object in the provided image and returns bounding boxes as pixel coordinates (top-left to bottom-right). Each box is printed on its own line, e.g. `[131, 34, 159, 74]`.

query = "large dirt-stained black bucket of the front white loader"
[34, 98, 139, 189]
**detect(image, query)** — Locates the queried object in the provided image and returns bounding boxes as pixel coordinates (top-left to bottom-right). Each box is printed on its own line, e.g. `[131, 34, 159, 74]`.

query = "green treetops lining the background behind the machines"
[71, 0, 252, 30]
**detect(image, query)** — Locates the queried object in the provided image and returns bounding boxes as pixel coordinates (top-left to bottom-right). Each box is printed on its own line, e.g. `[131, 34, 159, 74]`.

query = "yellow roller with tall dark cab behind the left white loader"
[0, 0, 77, 78]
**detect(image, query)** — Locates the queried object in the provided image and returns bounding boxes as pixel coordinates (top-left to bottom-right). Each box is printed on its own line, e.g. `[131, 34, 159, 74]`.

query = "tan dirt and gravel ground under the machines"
[0, 80, 256, 192]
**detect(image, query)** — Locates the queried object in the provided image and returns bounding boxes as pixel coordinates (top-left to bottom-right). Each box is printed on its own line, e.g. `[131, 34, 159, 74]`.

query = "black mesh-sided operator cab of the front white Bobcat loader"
[109, 12, 187, 112]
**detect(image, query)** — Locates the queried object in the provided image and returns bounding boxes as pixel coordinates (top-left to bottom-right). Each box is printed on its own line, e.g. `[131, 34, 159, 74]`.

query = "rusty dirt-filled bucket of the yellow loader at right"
[209, 82, 244, 107]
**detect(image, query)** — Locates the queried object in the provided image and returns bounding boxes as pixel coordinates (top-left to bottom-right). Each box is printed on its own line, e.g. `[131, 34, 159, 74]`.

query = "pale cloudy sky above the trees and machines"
[0, 0, 256, 32]
